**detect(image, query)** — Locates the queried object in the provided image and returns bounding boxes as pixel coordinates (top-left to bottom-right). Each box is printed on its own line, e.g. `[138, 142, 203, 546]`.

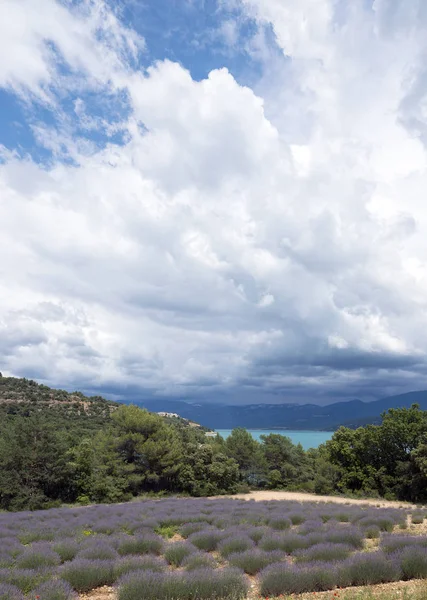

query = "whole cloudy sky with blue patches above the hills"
[0, 0, 427, 404]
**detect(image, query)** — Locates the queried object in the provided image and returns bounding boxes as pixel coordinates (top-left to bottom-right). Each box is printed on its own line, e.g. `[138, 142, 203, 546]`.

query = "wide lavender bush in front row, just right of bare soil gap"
[260, 563, 337, 596]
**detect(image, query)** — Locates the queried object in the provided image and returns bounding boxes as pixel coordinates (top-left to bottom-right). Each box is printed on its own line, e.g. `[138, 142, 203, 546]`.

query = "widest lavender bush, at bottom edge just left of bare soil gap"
[118, 569, 248, 600]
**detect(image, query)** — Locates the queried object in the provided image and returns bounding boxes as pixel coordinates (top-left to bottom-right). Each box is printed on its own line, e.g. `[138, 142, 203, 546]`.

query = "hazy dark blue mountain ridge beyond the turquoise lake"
[137, 390, 427, 431]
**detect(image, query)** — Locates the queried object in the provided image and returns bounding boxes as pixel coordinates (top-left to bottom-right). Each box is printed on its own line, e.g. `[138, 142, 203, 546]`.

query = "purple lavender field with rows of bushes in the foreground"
[0, 498, 427, 600]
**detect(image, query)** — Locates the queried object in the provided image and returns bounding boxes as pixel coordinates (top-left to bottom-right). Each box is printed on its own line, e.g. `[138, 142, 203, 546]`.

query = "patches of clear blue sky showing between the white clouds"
[0, 0, 274, 162]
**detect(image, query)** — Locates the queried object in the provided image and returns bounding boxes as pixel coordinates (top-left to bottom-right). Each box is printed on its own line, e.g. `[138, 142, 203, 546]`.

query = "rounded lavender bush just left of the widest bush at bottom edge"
[60, 558, 114, 592]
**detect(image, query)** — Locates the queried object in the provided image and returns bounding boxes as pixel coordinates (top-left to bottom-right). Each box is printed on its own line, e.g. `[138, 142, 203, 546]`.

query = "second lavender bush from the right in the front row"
[341, 552, 401, 585]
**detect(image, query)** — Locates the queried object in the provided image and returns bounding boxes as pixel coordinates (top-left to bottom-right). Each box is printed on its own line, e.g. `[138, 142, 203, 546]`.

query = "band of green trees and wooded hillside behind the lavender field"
[0, 378, 427, 511]
